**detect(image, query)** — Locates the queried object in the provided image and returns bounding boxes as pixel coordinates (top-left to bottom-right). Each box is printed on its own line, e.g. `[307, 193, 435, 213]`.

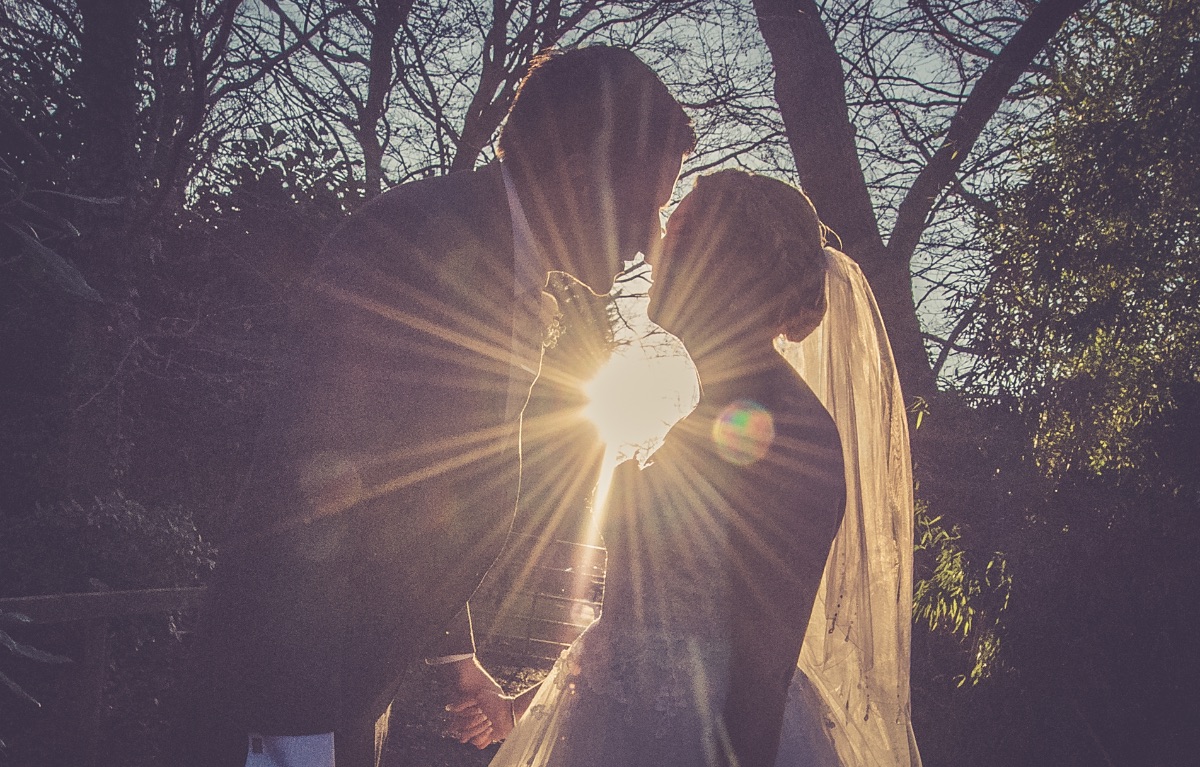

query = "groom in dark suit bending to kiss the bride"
[185, 47, 695, 767]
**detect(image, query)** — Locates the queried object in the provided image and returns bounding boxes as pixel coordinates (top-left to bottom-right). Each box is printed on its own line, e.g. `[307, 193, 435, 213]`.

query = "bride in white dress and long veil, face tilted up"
[451, 170, 920, 767]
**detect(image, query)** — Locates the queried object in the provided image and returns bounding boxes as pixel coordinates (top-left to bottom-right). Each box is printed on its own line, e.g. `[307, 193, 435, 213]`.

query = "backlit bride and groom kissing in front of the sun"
[181, 47, 919, 767]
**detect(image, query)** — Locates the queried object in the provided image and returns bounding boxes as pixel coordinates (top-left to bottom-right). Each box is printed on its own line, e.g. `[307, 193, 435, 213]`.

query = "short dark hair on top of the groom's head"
[498, 46, 696, 174]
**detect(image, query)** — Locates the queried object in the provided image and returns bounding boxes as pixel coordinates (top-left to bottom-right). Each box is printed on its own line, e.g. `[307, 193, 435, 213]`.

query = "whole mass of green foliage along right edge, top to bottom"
[931, 6, 1200, 765]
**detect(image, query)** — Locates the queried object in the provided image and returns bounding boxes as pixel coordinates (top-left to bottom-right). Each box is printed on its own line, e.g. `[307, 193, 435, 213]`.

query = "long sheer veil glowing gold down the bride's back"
[776, 247, 920, 767]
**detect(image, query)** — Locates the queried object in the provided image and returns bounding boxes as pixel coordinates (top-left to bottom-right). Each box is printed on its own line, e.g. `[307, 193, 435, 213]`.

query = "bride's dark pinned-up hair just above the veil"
[692, 169, 828, 342]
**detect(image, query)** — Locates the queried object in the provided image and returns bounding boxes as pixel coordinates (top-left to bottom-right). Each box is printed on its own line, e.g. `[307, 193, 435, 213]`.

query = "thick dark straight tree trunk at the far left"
[62, 0, 150, 499]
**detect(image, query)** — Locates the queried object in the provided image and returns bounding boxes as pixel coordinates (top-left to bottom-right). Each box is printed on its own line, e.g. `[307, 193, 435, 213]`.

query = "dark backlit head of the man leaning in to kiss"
[498, 46, 696, 293]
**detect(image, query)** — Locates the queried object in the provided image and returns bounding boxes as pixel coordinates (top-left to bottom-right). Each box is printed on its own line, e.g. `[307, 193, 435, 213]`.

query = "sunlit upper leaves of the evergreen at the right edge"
[971, 0, 1200, 483]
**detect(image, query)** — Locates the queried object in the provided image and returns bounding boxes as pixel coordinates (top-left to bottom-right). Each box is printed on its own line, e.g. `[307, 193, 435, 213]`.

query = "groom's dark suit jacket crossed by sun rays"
[194, 166, 545, 735]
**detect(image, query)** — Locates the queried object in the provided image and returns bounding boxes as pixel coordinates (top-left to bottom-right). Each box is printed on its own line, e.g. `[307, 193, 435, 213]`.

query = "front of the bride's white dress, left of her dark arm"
[492, 405, 728, 767]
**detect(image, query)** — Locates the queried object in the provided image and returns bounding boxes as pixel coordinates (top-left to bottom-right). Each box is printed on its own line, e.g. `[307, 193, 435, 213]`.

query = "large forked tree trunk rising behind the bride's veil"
[754, 0, 1087, 397]
